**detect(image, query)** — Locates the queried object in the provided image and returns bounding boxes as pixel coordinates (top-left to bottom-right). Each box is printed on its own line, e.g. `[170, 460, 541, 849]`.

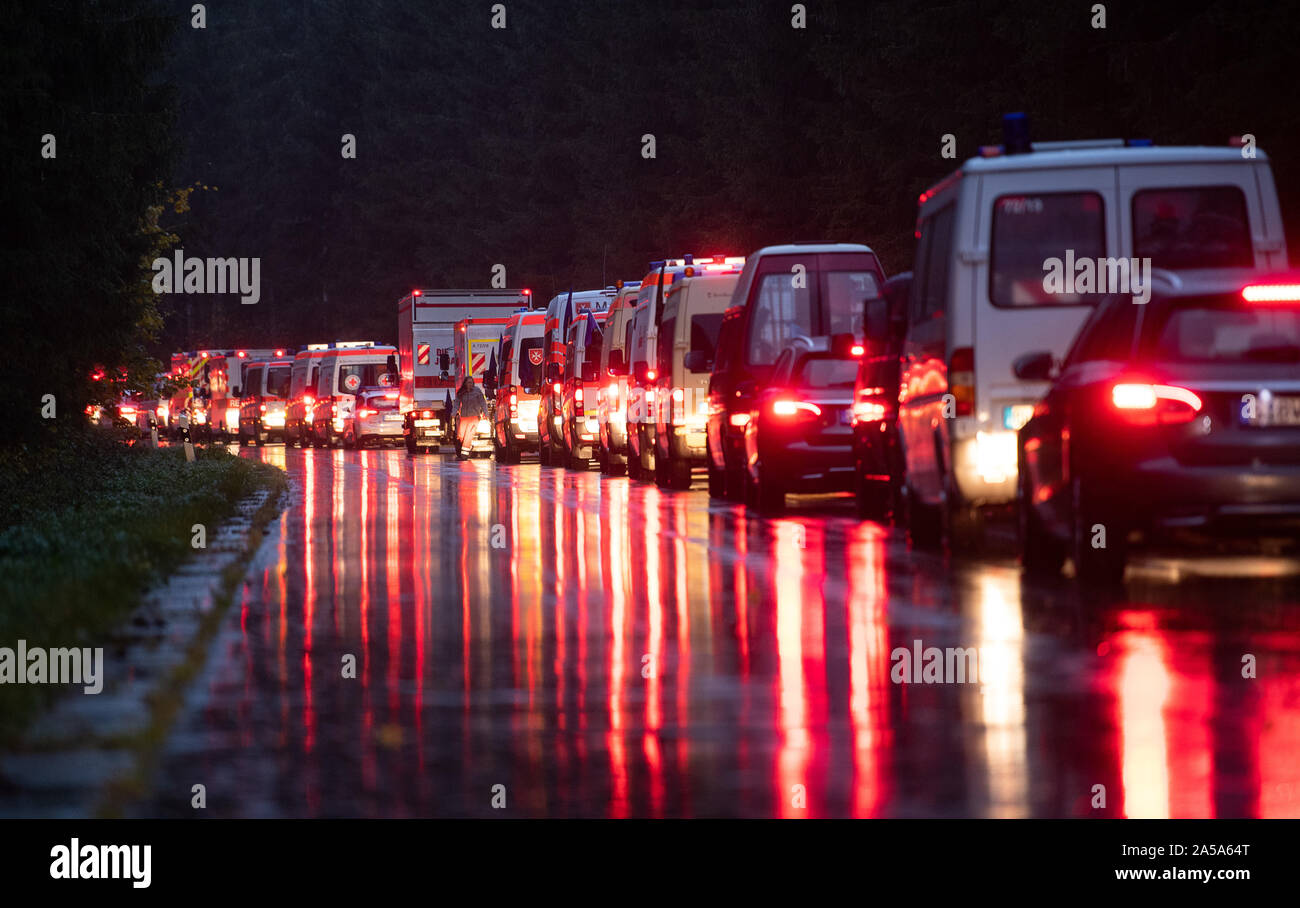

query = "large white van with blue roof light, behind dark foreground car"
[898, 114, 1287, 548]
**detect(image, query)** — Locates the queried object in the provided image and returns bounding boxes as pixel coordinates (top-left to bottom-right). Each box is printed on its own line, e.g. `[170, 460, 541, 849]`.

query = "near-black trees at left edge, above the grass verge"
[0, 0, 176, 438]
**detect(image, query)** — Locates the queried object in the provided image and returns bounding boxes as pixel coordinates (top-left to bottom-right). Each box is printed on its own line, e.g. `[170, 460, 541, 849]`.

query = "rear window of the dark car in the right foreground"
[1143, 299, 1300, 363]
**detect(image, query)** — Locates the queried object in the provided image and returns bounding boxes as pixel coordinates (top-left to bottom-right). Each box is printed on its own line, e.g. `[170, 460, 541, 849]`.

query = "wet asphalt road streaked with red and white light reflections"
[133, 446, 1300, 817]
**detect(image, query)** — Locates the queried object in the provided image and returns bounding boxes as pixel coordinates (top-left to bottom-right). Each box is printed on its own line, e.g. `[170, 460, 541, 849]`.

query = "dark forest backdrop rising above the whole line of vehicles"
[0, 0, 1300, 439]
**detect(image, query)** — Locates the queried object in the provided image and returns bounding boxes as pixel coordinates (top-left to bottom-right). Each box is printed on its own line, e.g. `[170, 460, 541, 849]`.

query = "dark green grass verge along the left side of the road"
[0, 429, 285, 744]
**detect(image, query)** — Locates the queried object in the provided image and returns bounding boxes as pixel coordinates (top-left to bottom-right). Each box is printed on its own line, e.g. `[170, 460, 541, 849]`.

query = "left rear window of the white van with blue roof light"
[988, 193, 1106, 307]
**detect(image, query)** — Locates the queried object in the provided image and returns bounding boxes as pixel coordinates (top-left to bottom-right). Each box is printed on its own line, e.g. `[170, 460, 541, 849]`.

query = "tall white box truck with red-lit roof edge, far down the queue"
[398, 290, 533, 454]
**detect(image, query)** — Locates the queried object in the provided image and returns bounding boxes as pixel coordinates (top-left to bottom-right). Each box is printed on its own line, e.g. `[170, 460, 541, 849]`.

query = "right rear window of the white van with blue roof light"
[1132, 186, 1255, 271]
